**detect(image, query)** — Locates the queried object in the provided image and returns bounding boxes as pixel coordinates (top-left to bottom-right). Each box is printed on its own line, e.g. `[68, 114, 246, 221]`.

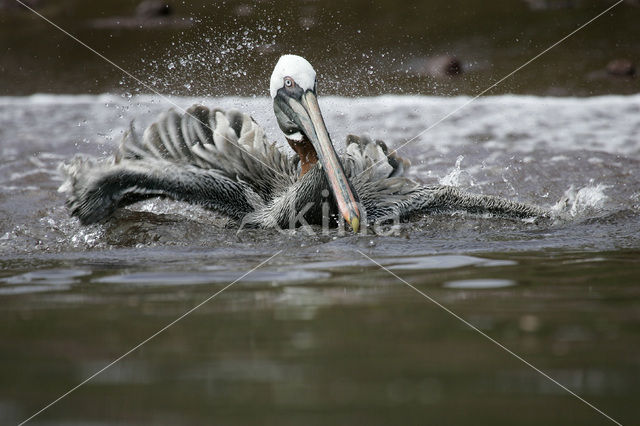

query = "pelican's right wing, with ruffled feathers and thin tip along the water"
[345, 135, 549, 222]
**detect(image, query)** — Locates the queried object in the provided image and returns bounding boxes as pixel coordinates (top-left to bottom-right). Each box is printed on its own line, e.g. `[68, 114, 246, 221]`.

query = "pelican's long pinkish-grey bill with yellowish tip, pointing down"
[288, 90, 360, 232]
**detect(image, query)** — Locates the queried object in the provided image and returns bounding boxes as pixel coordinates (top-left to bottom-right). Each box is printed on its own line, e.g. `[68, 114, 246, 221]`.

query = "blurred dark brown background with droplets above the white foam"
[0, 0, 640, 96]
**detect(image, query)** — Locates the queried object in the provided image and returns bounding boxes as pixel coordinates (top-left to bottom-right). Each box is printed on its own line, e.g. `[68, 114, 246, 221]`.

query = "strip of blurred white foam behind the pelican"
[0, 94, 640, 156]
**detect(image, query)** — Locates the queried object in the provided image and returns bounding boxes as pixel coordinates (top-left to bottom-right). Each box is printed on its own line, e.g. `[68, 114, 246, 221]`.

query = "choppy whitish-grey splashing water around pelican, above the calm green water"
[0, 93, 640, 253]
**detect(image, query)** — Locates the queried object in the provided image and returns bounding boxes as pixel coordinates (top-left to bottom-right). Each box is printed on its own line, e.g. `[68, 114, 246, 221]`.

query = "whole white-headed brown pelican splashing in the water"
[60, 55, 547, 232]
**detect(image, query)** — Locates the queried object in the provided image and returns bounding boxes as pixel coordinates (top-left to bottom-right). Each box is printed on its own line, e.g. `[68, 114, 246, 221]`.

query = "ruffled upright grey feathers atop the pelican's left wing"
[116, 105, 297, 199]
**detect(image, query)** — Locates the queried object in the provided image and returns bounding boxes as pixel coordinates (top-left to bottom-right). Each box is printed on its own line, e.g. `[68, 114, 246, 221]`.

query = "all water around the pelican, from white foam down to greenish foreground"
[0, 95, 640, 425]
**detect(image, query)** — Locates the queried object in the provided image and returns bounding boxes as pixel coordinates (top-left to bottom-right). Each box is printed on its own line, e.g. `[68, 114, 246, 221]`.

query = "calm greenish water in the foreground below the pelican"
[0, 248, 640, 425]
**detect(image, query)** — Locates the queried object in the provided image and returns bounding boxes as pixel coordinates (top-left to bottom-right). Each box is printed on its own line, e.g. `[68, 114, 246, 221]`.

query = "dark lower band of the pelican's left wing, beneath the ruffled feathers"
[58, 155, 263, 225]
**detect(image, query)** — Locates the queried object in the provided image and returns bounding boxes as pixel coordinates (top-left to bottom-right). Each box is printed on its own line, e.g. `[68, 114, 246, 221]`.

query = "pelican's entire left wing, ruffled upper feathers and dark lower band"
[60, 106, 296, 224]
